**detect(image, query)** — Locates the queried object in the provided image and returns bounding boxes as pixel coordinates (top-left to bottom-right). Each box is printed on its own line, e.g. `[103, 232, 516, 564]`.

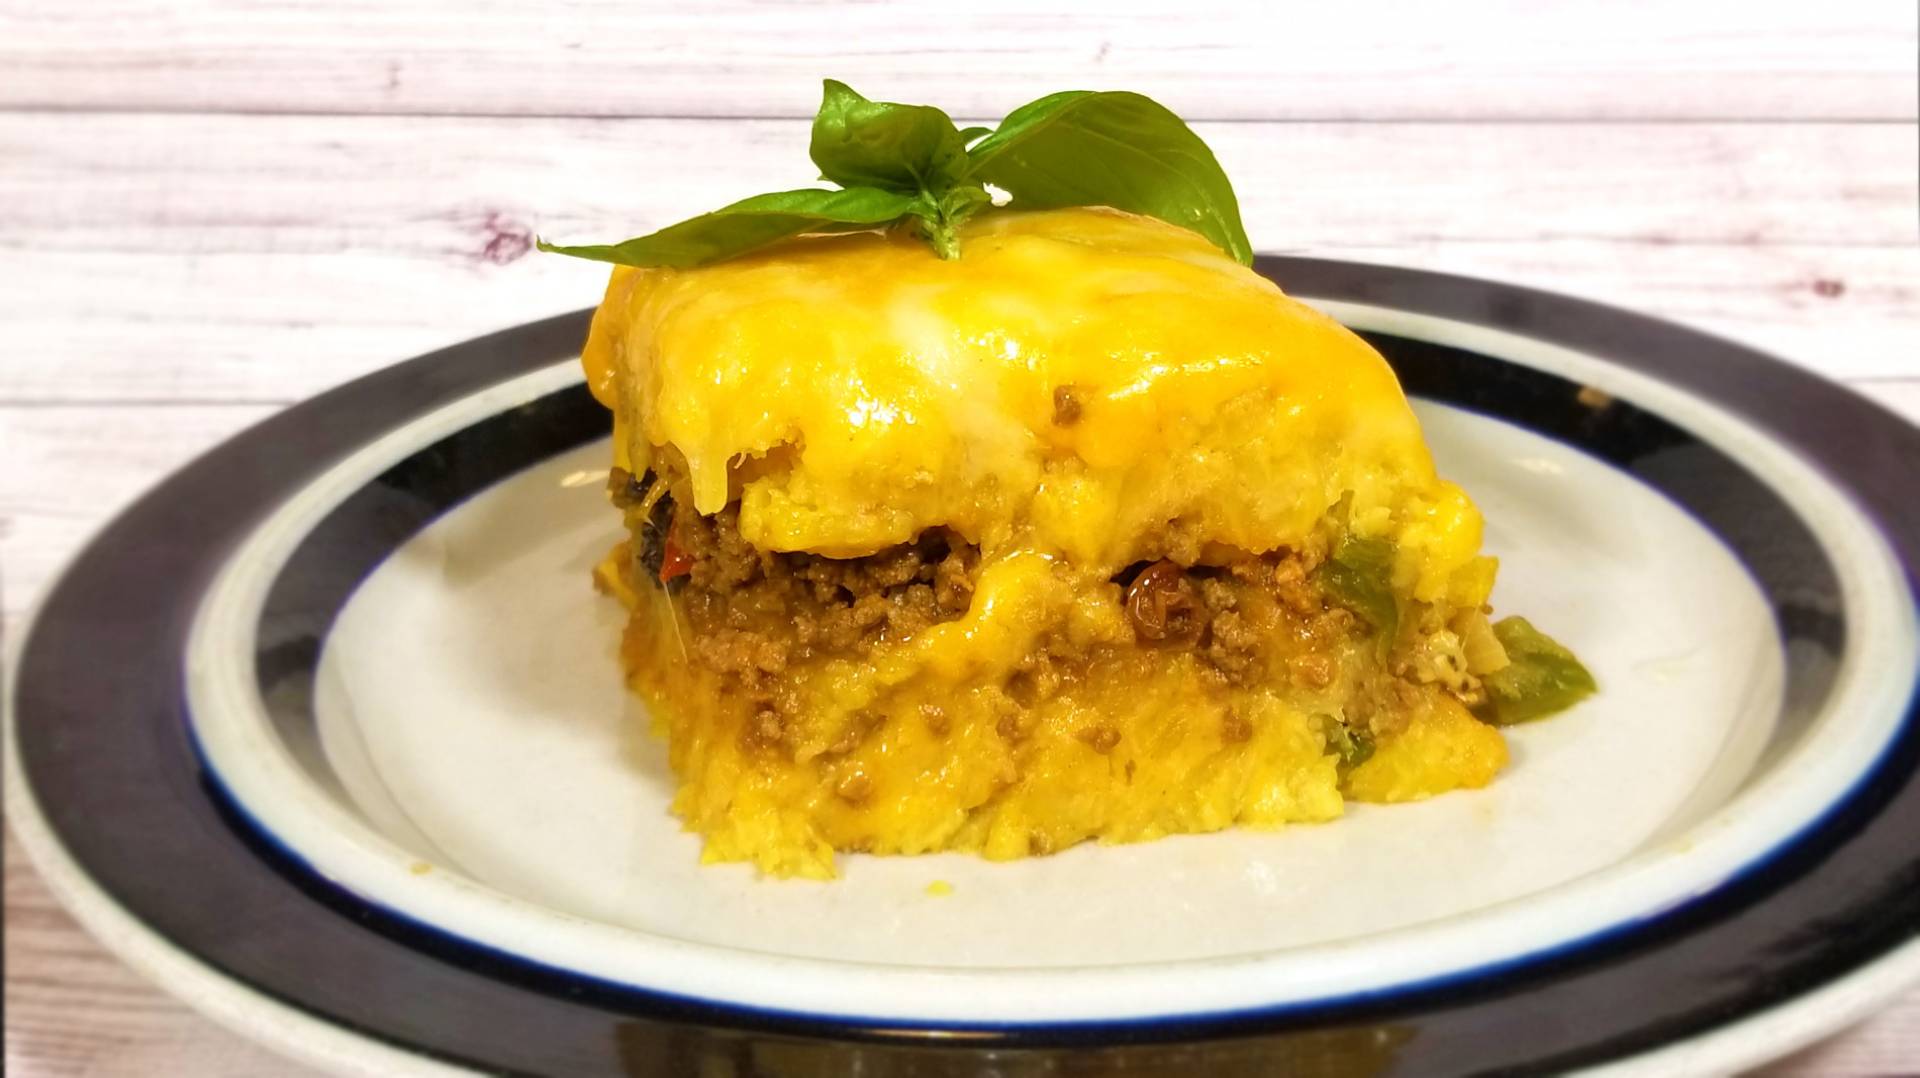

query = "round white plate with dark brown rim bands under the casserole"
[6, 257, 1920, 1074]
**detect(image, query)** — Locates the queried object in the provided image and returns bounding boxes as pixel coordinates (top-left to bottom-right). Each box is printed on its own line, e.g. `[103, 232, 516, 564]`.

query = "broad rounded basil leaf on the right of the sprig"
[968, 90, 1254, 265]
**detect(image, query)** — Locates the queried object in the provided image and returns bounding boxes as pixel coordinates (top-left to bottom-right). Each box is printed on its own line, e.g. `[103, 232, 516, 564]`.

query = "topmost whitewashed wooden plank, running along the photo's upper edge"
[0, 0, 1916, 119]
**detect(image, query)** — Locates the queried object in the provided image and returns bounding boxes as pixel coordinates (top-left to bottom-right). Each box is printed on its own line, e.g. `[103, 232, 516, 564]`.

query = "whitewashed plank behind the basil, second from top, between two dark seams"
[0, 113, 1920, 402]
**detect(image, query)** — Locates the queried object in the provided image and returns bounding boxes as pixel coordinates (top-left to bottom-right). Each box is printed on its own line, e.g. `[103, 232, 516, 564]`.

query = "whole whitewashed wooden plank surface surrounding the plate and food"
[0, 0, 1920, 1076]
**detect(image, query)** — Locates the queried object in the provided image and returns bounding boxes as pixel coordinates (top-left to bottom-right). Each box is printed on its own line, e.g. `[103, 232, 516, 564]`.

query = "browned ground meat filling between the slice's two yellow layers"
[609, 469, 1459, 757]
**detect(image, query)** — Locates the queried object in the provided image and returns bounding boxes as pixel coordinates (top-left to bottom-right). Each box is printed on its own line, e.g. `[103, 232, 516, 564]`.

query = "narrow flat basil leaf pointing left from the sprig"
[540, 186, 916, 269]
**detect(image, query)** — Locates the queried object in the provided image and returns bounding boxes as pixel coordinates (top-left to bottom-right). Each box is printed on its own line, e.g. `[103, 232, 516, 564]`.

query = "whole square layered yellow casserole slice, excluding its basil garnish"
[584, 209, 1536, 876]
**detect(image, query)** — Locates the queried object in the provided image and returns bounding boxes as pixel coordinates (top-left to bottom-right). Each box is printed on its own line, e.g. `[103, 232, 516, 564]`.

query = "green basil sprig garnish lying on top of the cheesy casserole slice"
[540, 79, 1254, 269]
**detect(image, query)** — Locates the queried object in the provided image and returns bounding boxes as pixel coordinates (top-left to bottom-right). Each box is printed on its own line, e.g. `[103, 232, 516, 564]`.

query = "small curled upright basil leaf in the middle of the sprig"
[808, 79, 966, 196]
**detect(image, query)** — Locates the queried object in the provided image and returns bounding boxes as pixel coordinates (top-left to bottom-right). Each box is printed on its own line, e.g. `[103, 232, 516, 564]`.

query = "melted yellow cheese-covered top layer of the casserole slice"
[584, 209, 1486, 601]
